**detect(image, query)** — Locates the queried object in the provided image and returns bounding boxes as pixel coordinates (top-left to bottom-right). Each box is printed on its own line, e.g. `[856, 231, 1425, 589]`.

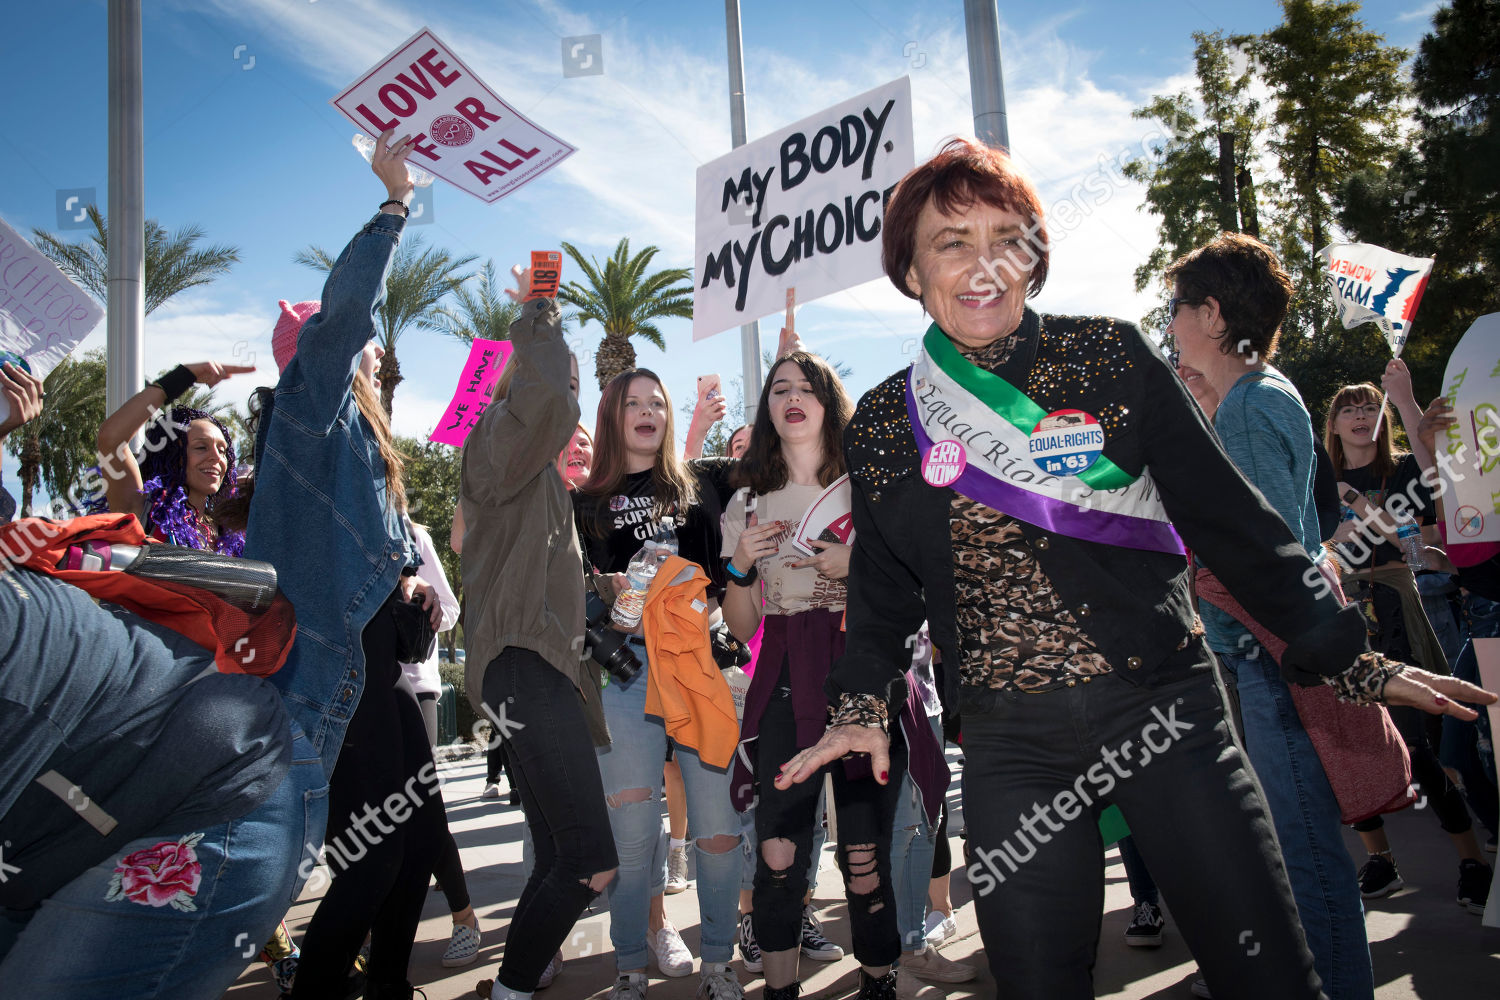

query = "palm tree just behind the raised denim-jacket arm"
[293, 235, 479, 417]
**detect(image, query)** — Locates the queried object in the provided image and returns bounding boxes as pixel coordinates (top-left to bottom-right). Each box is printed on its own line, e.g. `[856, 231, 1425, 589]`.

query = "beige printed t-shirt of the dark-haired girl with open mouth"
[720, 483, 849, 615]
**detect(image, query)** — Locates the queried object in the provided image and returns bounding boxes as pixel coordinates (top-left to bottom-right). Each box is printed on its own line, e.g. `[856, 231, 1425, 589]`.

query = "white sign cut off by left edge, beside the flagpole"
[0, 219, 104, 420]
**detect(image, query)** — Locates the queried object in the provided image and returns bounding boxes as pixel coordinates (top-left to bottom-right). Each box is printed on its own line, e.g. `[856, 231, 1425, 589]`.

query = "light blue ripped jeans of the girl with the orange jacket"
[599, 637, 744, 972]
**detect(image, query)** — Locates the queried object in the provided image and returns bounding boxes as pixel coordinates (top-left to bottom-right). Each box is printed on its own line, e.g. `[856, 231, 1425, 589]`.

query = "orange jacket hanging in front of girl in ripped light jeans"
[642, 556, 740, 768]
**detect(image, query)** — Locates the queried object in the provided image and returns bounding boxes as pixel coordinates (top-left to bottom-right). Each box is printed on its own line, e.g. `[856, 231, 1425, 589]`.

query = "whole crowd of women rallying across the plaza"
[0, 133, 1500, 1000]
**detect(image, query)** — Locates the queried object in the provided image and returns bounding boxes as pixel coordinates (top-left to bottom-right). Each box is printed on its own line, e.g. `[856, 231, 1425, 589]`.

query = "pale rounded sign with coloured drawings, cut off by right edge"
[1434, 312, 1500, 548]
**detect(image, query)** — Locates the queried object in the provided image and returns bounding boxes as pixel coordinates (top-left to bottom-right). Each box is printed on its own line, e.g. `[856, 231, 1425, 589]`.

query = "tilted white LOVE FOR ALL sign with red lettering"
[330, 28, 575, 201]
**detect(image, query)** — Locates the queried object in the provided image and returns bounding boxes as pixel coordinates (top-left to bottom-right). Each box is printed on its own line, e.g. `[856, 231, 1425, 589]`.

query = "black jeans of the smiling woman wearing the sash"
[963, 664, 1323, 1000]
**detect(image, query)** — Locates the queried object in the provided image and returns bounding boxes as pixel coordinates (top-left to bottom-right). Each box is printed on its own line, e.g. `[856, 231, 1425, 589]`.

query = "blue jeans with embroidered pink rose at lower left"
[0, 723, 329, 1000]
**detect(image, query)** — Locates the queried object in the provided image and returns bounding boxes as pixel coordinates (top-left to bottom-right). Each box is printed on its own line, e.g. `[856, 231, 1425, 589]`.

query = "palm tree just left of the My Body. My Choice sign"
[558, 237, 693, 388]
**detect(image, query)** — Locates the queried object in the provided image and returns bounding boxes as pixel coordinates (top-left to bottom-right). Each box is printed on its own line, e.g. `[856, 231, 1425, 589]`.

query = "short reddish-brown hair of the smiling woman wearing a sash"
[881, 139, 1052, 298]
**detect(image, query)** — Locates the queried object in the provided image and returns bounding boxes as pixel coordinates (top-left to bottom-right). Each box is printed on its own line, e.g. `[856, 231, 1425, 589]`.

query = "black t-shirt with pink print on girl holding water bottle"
[573, 459, 735, 598]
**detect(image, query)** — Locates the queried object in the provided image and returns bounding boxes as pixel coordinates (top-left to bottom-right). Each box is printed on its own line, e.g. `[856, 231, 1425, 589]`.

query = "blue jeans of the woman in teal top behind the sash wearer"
[1218, 645, 1374, 1000]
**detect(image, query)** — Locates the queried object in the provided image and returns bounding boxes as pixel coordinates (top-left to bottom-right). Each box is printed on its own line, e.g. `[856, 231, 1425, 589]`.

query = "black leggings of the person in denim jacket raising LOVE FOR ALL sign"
[293, 609, 446, 1000]
